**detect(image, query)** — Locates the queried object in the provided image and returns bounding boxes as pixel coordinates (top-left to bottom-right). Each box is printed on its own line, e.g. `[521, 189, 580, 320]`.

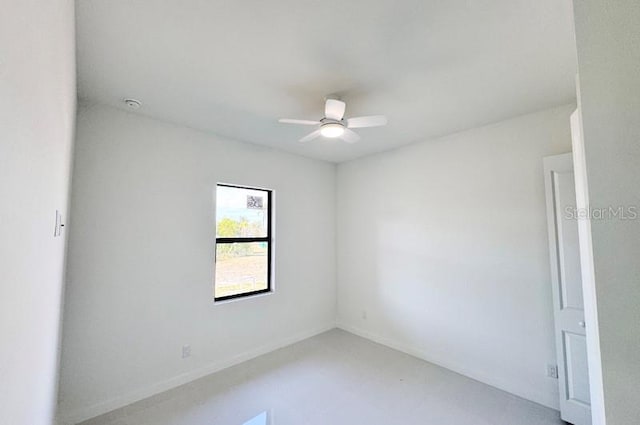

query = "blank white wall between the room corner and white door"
[337, 106, 574, 408]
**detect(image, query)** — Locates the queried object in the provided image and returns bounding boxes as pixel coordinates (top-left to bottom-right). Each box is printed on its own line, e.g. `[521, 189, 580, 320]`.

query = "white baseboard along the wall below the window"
[57, 323, 336, 425]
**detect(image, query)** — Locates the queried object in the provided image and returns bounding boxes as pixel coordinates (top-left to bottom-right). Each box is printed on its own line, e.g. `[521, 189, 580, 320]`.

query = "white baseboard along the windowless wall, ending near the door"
[336, 322, 559, 410]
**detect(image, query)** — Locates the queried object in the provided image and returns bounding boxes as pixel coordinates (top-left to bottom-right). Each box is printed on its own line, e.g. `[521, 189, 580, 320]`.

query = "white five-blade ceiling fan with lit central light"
[279, 99, 387, 143]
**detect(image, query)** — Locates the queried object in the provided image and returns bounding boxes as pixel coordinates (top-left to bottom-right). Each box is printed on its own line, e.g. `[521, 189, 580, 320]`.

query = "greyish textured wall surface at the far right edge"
[574, 0, 640, 425]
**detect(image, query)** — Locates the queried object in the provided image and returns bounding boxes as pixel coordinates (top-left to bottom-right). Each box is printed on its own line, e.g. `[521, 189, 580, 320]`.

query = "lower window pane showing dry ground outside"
[214, 242, 269, 298]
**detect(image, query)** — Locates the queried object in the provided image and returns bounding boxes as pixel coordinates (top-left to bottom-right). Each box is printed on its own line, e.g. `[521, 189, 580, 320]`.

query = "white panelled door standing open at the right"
[544, 153, 591, 425]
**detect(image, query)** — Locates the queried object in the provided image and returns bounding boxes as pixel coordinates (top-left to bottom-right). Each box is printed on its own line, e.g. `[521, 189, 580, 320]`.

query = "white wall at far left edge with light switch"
[0, 0, 76, 425]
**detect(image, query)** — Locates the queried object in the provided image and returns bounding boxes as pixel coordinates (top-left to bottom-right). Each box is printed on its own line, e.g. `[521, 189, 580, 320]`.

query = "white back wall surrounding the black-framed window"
[60, 106, 336, 421]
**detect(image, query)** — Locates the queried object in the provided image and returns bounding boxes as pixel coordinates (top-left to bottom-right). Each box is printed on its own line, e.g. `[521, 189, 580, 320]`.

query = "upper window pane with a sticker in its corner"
[216, 186, 269, 238]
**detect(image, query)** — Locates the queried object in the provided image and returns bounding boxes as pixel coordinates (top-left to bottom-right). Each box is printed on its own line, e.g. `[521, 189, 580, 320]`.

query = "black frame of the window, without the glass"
[213, 183, 273, 302]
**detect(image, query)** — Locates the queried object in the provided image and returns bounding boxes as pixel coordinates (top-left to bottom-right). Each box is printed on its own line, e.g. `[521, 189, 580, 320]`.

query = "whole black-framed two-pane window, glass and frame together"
[214, 184, 271, 301]
